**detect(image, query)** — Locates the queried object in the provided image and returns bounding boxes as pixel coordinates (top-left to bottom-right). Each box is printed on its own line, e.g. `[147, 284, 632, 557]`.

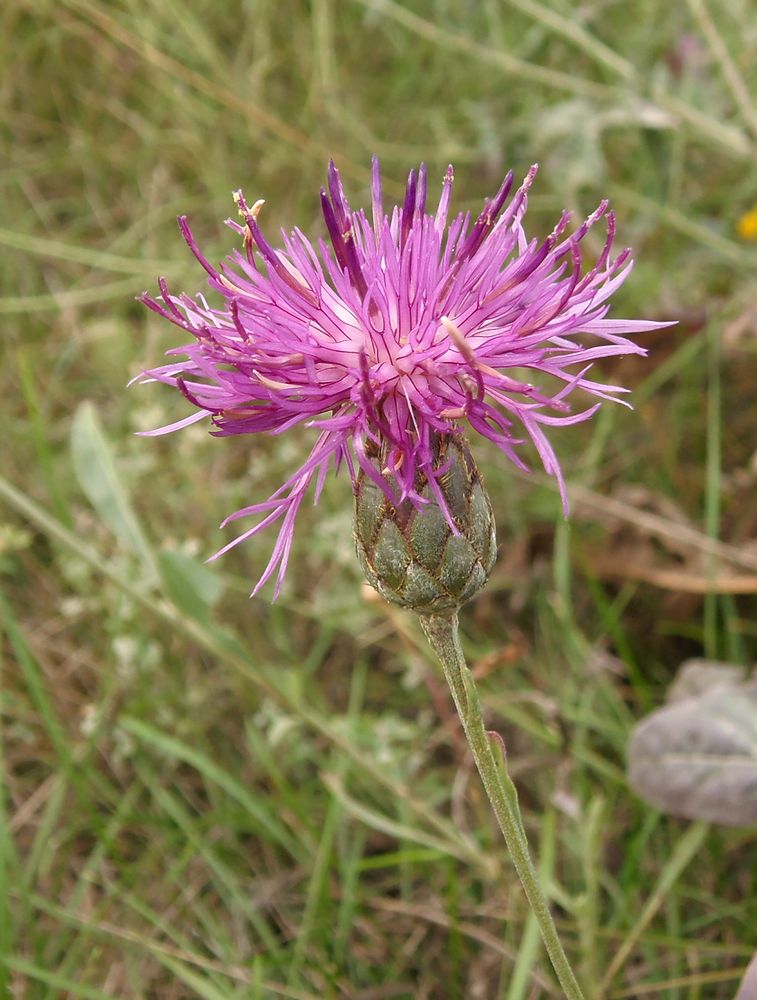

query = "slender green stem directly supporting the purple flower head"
[419, 612, 583, 1000]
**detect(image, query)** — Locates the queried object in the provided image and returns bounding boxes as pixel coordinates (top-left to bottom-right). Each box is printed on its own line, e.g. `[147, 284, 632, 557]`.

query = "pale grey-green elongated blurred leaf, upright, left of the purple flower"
[71, 402, 157, 580]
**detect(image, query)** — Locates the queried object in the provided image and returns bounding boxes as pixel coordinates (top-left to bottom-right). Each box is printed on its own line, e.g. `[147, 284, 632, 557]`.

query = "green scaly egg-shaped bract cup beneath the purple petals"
[355, 434, 497, 614]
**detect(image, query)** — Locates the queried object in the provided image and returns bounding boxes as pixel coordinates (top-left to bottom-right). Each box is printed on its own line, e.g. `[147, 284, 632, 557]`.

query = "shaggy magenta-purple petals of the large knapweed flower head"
[142, 159, 666, 596]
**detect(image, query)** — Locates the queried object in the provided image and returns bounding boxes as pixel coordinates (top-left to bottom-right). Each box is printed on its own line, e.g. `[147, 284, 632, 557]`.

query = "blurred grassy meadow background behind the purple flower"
[0, 0, 757, 1000]
